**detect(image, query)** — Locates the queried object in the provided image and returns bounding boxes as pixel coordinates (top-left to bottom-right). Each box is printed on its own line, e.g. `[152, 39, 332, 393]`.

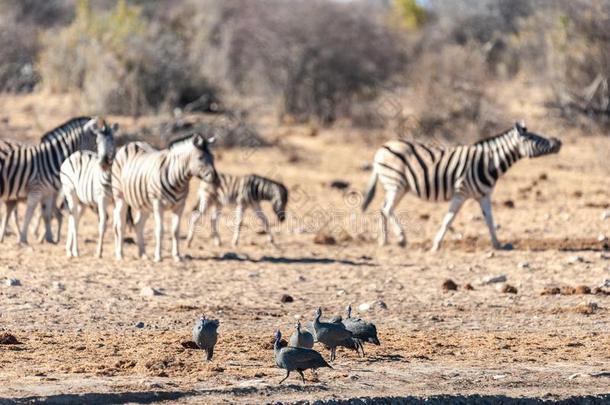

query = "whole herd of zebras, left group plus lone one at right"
[0, 117, 561, 261]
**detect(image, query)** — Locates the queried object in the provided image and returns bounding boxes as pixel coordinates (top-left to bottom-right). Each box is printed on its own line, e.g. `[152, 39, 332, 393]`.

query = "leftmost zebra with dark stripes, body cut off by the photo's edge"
[0, 117, 108, 244]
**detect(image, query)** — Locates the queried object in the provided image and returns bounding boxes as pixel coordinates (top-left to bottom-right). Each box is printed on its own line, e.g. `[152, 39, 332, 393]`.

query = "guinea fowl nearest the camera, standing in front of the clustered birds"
[273, 330, 332, 384]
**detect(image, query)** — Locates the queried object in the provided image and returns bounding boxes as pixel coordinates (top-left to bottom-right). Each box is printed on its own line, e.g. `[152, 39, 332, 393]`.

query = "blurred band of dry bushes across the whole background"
[0, 0, 610, 138]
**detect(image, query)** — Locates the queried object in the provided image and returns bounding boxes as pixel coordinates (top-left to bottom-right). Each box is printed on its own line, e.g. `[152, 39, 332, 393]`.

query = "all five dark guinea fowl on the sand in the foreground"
[193, 305, 380, 384]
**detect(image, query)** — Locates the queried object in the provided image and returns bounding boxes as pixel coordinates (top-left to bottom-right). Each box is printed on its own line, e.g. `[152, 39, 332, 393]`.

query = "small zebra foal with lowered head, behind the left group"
[187, 173, 288, 247]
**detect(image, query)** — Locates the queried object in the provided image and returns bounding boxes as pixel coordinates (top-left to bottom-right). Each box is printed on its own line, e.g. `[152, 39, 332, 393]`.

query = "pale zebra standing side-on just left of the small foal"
[112, 134, 216, 261]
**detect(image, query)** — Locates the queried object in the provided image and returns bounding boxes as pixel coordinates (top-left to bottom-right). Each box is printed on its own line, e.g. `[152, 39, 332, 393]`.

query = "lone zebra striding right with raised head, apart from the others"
[362, 123, 561, 251]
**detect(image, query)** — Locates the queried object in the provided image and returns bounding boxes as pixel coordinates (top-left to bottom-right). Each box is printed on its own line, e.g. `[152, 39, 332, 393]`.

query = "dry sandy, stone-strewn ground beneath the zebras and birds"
[0, 100, 610, 403]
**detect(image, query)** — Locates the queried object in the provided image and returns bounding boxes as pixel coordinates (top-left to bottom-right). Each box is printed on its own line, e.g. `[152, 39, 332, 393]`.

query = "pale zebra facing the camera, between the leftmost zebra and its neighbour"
[59, 123, 119, 258]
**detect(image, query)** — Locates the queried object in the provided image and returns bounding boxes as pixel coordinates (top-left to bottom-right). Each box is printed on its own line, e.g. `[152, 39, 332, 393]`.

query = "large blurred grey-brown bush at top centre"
[182, 0, 405, 124]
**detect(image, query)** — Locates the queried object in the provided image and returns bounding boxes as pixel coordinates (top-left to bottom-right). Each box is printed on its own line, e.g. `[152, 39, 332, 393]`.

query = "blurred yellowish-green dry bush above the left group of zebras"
[39, 0, 215, 115]
